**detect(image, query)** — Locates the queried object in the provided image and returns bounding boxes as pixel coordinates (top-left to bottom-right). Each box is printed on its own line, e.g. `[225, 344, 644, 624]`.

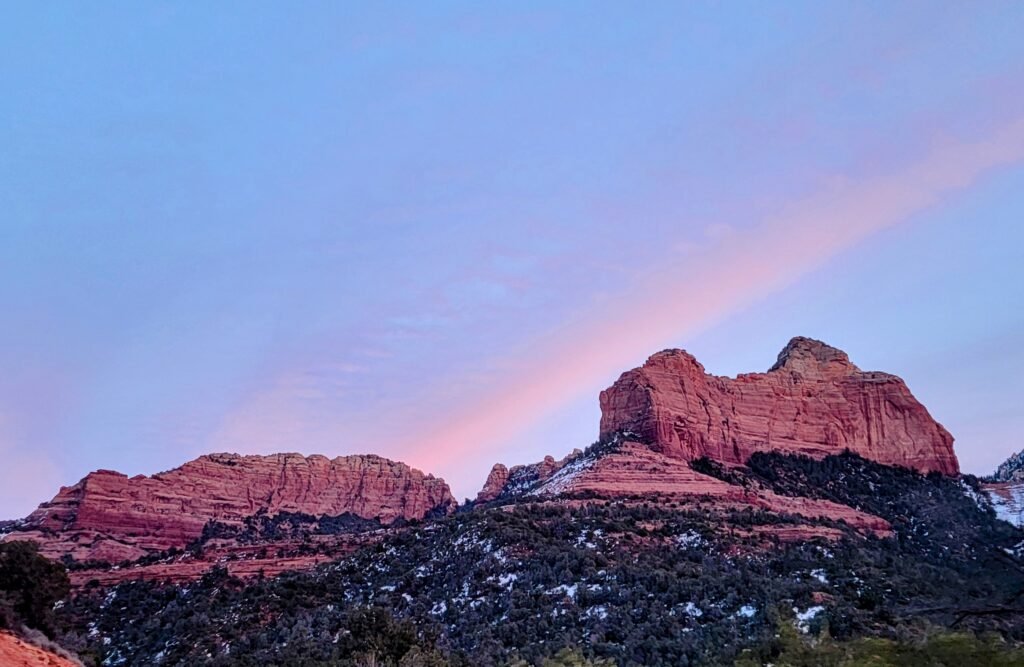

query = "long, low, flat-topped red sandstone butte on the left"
[6, 454, 457, 561]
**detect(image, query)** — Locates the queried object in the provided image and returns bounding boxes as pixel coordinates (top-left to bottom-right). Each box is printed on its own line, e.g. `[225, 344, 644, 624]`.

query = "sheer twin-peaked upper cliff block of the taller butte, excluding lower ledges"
[601, 338, 959, 474]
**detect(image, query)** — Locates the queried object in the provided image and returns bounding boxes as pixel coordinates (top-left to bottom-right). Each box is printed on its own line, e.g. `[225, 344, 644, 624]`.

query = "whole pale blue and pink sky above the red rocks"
[0, 1, 1024, 517]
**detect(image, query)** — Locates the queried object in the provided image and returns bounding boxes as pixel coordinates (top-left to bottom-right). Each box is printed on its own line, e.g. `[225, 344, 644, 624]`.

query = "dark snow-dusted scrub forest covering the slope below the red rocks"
[54, 455, 1024, 667]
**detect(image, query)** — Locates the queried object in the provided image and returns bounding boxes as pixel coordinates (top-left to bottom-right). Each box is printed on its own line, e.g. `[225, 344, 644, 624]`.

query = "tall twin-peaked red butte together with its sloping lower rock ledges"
[477, 338, 958, 533]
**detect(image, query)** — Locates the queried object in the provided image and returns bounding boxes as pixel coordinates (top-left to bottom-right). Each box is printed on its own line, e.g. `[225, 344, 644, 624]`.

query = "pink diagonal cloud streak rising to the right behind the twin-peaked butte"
[393, 118, 1024, 489]
